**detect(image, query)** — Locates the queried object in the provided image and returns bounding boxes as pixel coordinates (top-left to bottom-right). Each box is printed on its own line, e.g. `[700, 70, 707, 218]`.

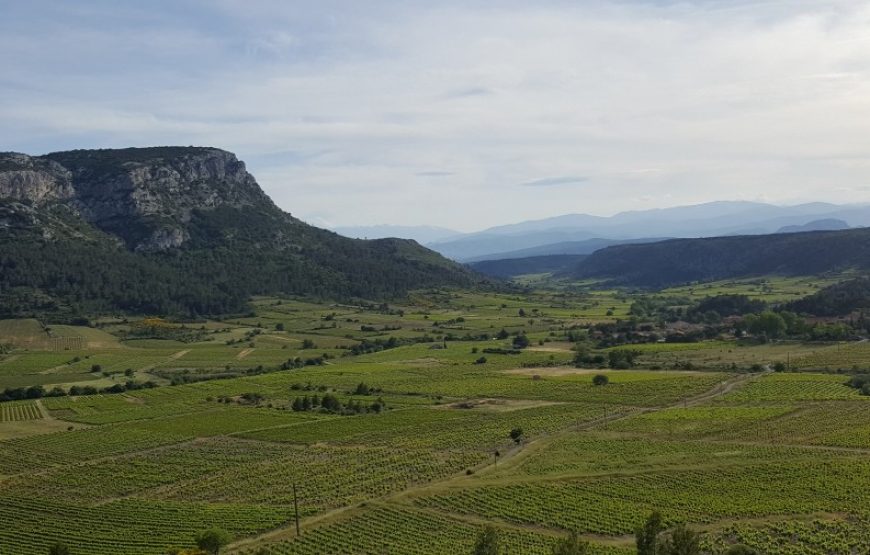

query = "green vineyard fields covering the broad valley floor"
[0, 286, 870, 555]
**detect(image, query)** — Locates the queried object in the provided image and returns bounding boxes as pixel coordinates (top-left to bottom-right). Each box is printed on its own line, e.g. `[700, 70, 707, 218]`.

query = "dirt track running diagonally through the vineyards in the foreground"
[227, 370, 770, 554]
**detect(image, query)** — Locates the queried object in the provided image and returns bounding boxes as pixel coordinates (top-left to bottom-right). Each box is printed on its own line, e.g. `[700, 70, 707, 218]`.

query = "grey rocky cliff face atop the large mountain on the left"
[0, 147, 278, 250]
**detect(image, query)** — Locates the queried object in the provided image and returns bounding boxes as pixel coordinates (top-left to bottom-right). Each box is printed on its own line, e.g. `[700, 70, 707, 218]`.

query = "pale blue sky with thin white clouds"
[0, 0, 870, 231]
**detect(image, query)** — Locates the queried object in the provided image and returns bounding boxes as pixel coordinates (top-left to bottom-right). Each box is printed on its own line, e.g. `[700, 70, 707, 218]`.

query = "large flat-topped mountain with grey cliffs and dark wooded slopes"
[0, 147, 478, 317]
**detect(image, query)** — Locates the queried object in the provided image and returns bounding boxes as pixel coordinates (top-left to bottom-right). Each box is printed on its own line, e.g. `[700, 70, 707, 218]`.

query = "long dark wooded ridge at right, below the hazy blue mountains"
[565, 228, 870, 287]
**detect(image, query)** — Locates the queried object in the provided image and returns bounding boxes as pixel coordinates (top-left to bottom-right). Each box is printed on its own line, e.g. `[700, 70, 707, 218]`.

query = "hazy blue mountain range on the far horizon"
[427, 201, 870, 262]
